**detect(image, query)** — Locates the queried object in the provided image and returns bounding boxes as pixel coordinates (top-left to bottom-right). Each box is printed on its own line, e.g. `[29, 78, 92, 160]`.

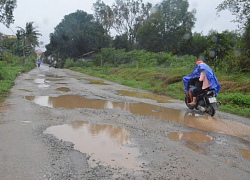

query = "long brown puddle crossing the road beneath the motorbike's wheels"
[25, 95, 250, 137]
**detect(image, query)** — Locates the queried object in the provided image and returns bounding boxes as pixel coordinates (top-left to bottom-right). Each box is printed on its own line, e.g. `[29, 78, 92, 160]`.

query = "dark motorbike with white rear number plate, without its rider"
[185, 89, 221, 116]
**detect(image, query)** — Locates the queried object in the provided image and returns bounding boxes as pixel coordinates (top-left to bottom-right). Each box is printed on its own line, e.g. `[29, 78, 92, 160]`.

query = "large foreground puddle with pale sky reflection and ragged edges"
[44, 121, 145, 170]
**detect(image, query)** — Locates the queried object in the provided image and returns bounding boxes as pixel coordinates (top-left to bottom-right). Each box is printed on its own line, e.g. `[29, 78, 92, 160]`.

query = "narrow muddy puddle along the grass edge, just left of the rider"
[116, 90, 171, 103]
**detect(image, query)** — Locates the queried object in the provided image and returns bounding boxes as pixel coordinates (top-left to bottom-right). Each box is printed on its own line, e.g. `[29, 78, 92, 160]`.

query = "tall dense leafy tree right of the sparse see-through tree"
[138, 0, 196, 54]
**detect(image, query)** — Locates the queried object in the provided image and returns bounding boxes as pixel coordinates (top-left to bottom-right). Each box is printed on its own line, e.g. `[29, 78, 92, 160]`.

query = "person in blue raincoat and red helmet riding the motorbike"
[183, 60, 221, 106]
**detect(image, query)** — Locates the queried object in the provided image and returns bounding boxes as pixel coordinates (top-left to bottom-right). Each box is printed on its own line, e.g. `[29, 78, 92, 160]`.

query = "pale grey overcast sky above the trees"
[0, 0, 237, 50]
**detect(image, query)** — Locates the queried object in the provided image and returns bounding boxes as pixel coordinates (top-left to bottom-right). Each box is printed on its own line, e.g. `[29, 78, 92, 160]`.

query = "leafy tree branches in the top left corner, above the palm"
[0, 0, 16, 27]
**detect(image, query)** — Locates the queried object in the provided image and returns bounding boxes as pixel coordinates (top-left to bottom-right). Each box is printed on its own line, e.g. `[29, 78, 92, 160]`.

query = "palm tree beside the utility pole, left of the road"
[17, 22, 42, 56]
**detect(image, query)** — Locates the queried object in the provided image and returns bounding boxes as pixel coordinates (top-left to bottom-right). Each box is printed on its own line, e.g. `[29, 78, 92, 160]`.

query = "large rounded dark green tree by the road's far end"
[46, 10, 109, 58]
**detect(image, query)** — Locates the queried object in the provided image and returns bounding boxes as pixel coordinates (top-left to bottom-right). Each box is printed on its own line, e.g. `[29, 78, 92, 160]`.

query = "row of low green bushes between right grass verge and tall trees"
[93, 48, 197, 68]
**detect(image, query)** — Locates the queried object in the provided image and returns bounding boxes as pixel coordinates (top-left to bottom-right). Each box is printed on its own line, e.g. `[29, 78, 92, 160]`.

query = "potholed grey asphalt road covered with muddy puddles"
[0, 65, 250, 180]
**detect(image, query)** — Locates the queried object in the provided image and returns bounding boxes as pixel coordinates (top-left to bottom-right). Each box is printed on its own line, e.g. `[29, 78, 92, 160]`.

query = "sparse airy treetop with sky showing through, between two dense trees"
[93, 0, 152, 49]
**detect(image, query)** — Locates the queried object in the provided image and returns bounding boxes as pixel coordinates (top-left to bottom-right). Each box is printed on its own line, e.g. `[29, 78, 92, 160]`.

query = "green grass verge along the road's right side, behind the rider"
[70, 67, 250, 118]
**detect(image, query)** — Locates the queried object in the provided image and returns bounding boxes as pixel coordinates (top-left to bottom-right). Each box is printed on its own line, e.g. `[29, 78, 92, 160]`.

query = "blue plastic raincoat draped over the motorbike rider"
[183, 63, 221, 96]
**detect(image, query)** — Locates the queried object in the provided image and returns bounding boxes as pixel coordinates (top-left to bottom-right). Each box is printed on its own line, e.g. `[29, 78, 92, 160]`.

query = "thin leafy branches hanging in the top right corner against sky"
[217, 0, 250, 25]
